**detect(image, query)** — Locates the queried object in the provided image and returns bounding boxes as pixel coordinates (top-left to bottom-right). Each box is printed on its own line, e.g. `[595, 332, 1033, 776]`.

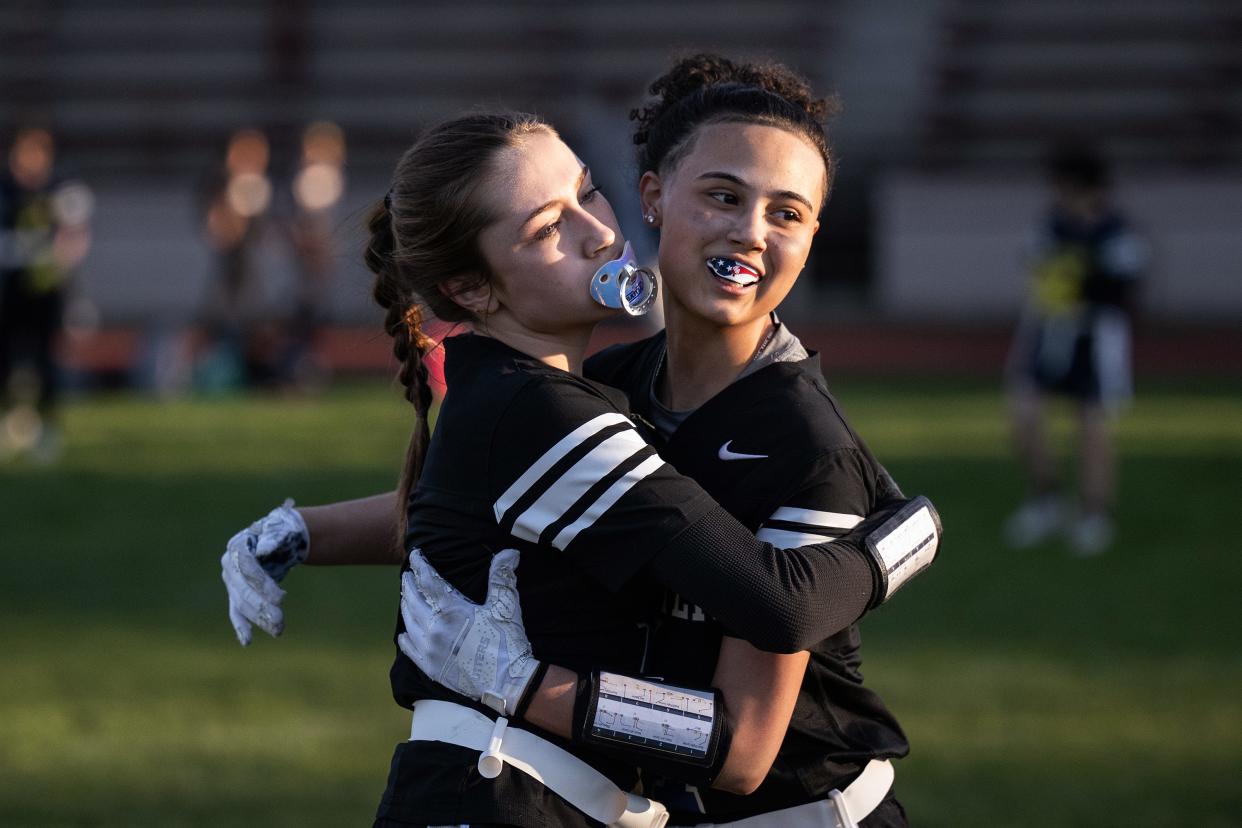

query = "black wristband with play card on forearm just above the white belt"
[574, 670, 733, 786]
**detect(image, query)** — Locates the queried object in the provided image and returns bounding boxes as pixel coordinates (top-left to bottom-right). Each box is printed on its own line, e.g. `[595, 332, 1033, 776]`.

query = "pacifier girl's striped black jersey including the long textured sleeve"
[379, 335, 876, 826]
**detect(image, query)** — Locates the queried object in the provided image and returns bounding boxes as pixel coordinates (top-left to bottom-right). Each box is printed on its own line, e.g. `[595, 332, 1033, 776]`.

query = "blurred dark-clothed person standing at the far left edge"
[0, 128, 93, 463]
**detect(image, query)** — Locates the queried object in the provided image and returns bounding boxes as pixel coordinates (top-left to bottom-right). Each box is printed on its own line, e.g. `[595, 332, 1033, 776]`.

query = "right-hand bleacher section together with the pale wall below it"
[873, 0, 1242, 330]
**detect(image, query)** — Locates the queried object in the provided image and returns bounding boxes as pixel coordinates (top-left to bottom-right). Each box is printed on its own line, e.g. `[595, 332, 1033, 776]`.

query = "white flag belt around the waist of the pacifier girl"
[410, 699, 668, 828]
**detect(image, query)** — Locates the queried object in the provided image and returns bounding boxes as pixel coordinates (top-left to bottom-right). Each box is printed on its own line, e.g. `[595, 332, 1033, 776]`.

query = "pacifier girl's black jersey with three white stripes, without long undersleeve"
[379, 335, 713, 826]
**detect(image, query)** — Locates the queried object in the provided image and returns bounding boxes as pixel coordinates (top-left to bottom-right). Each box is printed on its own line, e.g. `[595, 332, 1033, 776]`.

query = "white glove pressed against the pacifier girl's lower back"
[397, 549, 539, 716]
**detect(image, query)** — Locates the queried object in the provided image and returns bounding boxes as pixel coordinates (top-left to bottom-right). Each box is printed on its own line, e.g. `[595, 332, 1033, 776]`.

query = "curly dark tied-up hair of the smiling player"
[630, 53, 840, 206]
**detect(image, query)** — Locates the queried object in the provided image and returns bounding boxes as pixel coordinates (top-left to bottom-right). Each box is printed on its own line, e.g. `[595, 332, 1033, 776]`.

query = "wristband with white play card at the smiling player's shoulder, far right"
[856, 495, 943, 606]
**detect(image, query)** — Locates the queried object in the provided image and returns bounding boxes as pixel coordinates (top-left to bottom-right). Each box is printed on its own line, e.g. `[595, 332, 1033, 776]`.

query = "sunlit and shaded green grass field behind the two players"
[0, 381, 1242, 828]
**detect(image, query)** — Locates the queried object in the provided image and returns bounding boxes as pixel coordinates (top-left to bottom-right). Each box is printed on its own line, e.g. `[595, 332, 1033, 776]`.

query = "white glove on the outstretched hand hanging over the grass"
[220, 500, 311, 647]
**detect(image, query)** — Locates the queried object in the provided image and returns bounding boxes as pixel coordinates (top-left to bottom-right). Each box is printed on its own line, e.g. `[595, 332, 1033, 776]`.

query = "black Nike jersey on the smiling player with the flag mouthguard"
[586, 333, 909, 823]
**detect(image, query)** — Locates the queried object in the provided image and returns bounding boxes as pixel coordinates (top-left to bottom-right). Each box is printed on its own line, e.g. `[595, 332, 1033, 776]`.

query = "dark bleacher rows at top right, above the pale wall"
[920, 0, 1242, 166]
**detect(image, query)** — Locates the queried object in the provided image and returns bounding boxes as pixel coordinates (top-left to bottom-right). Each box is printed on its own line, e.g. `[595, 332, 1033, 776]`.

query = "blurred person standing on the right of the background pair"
[277, 122, 345, 387]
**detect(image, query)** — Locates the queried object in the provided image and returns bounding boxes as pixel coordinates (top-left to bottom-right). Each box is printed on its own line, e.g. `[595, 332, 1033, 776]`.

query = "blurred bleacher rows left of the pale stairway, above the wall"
[0, 0, 832, 178]
